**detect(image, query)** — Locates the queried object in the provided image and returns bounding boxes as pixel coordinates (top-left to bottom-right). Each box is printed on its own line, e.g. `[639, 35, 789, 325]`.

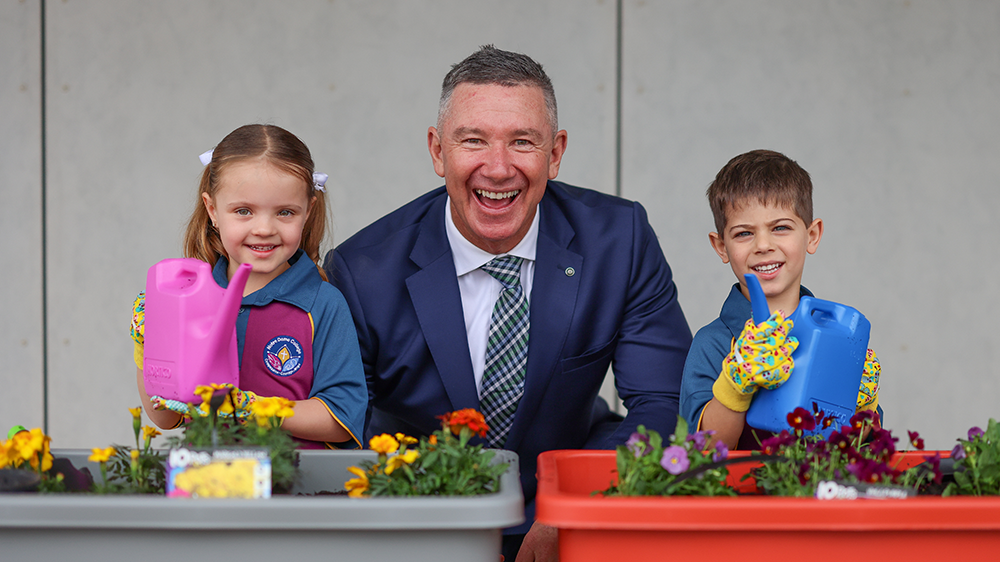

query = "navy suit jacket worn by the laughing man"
[324, 181, 691, 532]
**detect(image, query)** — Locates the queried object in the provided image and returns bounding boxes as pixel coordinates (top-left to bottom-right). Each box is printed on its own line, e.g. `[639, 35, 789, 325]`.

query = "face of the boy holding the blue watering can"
[708, 200, 823, 314]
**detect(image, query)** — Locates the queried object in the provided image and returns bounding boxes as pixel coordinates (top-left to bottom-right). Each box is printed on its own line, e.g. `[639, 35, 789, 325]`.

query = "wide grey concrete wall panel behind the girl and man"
[47, 0, 615, 447]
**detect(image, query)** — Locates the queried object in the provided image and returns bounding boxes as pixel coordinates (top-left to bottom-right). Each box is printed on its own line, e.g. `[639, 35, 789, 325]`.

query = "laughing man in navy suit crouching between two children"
[325, 46, 691, 560]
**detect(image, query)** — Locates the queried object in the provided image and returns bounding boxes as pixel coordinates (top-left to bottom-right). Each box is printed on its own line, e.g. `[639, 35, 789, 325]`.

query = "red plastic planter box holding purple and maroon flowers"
[536, 451, 1000, 562]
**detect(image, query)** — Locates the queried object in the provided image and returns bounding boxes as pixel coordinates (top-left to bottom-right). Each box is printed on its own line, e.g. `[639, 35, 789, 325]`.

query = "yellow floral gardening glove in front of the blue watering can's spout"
[712, 311, 799, 412]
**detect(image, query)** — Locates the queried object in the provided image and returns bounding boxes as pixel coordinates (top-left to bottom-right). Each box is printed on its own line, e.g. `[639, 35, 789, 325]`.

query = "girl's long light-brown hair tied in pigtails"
[184, 125, 326, 280]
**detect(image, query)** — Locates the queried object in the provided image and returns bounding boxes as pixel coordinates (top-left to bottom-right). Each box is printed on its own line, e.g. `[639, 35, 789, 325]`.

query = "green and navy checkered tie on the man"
[479, 256, 528, 448]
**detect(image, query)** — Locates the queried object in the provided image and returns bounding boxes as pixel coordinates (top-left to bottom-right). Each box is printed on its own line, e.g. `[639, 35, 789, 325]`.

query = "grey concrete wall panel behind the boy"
[623, 0, 1000, 449]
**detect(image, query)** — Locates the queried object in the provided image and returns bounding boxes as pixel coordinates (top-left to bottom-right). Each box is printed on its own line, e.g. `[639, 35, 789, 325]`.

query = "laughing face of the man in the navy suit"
[427, 83, 566, 254]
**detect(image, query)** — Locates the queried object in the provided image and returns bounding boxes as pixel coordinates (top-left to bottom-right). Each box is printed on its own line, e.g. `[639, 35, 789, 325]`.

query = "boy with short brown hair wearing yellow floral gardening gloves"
[680, 150, 880, 449]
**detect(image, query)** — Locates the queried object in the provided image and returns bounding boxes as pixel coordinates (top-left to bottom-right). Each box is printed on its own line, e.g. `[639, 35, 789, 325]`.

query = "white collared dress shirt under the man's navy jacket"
[444, 197, 541, 397]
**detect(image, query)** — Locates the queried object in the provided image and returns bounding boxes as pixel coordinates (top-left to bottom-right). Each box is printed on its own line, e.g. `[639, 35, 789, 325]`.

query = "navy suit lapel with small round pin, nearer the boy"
[505, 198, 584, 449]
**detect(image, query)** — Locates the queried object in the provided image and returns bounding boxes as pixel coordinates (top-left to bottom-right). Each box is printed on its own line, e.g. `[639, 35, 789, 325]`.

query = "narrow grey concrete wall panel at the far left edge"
[0, 1, 44, 439]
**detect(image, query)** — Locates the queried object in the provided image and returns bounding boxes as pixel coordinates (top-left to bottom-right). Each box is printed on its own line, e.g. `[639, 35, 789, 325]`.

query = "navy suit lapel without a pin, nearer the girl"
[406, 197, 479, 414]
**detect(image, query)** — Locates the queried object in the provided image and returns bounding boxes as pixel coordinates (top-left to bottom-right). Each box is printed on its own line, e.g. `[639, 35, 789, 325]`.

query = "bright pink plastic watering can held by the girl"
[142, 258, 253, 402]
